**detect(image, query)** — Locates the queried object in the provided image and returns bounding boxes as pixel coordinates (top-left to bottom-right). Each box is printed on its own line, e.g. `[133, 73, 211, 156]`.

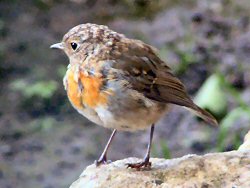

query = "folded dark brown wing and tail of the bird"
[112, 39, 217, 125]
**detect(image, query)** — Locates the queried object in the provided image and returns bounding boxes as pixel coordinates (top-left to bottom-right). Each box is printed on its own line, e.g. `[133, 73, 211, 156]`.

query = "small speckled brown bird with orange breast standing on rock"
[51, 23, 217, 169]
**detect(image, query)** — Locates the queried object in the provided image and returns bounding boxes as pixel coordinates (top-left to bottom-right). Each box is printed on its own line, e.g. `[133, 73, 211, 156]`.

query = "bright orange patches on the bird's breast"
[67, 70, 108, 109]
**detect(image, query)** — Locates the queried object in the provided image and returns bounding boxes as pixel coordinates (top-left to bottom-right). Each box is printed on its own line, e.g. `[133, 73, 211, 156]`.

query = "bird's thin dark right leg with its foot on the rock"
[127, 124, 155, 170]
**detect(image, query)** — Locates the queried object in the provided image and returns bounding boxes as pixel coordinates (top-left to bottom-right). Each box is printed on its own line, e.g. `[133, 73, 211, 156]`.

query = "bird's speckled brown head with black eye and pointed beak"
[50, 23, 122, 63]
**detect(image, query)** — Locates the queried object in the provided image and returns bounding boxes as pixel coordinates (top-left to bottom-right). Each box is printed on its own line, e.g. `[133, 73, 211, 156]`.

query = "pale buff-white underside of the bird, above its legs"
[76, 90, 167, 131]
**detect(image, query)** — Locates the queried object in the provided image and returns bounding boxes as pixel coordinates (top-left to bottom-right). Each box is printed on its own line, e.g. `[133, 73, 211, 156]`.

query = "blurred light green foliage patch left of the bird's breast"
[10, 80, 58, 99]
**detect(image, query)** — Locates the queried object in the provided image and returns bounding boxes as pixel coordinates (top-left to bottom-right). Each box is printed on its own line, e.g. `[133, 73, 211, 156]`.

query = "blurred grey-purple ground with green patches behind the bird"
[0, 0, 250, 188]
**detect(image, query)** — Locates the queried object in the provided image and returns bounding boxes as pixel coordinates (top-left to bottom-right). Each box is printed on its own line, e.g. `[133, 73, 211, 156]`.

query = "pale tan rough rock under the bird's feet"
[70, 151, 250, 188]
